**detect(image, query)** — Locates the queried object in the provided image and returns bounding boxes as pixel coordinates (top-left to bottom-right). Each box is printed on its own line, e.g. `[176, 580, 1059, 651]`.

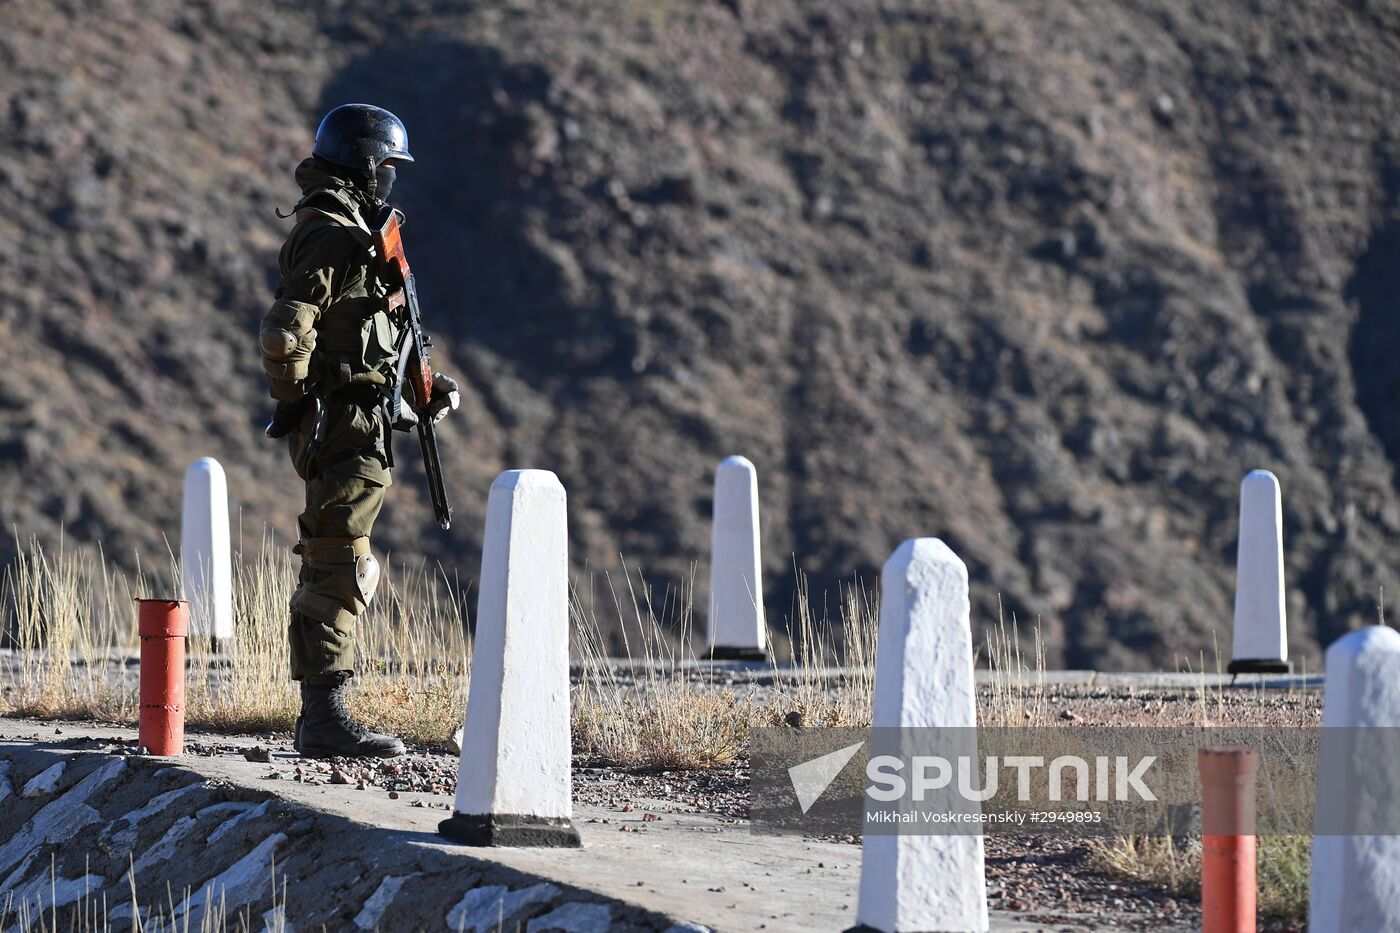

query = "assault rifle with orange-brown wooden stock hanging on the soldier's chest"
[374, 205, 452, 531]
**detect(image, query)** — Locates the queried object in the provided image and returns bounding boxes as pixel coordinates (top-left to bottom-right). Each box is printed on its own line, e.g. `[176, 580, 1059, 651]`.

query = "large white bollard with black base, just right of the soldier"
[438, 469, 580, 846]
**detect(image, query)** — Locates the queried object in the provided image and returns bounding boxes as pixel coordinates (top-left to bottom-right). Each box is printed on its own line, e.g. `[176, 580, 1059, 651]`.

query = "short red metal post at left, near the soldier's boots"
[137, 600, 189, 755]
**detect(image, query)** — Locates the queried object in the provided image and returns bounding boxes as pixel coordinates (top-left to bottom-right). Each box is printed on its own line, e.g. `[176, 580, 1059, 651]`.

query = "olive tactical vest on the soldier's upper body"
[294, 188, 402, 395]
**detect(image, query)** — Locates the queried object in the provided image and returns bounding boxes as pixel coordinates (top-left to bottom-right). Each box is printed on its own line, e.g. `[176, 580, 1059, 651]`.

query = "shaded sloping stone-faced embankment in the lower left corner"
[0, 720, 688, 933]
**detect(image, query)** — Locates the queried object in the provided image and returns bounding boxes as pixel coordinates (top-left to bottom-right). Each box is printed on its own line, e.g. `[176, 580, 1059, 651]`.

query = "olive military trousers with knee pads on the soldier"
[287, 399, 391, 684]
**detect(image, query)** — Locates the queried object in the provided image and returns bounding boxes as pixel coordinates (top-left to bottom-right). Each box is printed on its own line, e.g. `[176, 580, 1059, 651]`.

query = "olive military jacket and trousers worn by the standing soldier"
[262, 158, 399, 682]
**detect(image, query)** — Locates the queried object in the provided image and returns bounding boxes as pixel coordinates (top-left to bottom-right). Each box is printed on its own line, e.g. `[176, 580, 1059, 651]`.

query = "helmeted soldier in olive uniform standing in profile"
[259, 104, 459, 756]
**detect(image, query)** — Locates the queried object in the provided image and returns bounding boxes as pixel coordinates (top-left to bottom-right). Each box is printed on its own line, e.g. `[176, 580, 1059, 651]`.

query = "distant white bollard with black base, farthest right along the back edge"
[1229, 469, 1291, 674]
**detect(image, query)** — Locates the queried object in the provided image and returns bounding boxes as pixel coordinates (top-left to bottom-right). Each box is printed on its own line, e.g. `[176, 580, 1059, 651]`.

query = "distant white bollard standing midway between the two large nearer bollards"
[707, 457, 767, 661]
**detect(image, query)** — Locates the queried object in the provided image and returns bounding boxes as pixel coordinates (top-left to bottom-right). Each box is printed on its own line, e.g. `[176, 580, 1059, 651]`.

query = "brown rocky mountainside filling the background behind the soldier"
[0, 0, 1400, 668]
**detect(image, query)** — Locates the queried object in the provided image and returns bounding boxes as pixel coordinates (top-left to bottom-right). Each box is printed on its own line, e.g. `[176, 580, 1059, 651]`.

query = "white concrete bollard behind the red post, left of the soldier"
[179, 457, 234, 643]
